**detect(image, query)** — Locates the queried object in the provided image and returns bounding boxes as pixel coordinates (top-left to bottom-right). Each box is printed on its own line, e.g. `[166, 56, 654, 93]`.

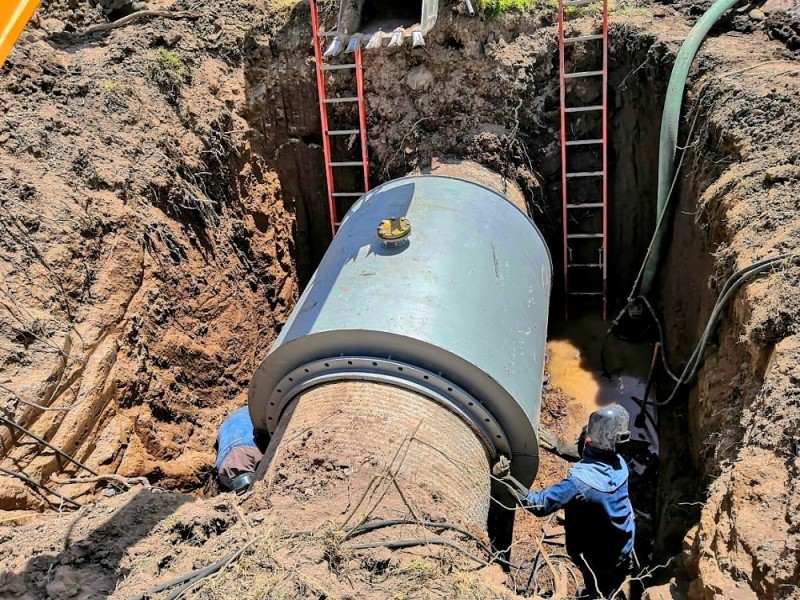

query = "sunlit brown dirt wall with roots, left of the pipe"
[0, 2, 297, 508]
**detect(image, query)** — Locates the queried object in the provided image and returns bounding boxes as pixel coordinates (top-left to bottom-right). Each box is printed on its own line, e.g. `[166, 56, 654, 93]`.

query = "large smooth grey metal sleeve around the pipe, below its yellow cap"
[250, 175, 552, 483]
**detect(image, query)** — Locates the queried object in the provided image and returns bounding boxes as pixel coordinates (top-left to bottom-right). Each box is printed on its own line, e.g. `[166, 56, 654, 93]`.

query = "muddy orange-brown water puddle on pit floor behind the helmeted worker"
[547, 316, 658, 462]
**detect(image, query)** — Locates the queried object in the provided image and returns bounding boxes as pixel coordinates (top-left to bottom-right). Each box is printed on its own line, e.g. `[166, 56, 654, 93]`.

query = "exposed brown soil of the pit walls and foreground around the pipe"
[0, 0, 800, 600]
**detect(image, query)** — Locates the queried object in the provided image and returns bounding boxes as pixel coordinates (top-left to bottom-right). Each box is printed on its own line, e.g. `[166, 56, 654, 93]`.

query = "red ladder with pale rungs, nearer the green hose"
[558, 0, 608, 319]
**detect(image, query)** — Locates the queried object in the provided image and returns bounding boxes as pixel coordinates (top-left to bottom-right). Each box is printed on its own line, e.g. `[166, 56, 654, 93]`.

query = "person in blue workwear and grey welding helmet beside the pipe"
[521, 404, 635, 600]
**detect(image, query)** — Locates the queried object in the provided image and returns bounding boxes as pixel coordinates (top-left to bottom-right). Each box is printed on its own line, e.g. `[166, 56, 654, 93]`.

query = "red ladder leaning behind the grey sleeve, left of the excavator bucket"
[309, 0, 369, 235]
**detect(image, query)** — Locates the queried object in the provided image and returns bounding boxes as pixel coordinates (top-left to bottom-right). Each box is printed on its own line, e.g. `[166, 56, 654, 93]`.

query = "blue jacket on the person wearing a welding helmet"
[526, 448, 635, 569]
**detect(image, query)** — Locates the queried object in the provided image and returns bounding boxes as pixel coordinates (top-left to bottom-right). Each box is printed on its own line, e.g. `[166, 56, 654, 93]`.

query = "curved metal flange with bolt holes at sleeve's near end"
[267, 356, 511, 459]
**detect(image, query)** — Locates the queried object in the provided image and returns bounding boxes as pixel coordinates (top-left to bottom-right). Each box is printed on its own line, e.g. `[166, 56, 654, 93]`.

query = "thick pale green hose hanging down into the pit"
[631, 0, 740, 298]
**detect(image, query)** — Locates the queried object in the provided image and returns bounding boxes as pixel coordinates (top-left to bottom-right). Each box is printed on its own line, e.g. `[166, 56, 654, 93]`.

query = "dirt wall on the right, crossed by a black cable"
[662, 29, 800, 600]
